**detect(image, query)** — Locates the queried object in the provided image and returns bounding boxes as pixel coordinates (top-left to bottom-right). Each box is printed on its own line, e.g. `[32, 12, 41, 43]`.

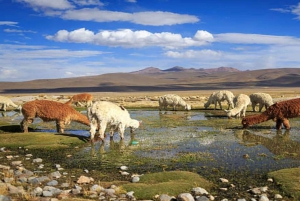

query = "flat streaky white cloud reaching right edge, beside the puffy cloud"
[214, 33, 300, 45]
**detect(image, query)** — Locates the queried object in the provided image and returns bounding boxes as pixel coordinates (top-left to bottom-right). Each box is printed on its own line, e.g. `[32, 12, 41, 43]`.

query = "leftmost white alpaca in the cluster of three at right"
[204, 90, 234, 110]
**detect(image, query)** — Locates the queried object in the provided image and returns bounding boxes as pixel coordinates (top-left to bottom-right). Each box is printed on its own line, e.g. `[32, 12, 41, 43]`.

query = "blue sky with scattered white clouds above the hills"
[0, 0, 300, 81]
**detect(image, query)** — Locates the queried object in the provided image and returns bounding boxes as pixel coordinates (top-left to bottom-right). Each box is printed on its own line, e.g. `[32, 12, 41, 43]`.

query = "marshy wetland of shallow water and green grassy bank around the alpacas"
[0, 90, 300, 200]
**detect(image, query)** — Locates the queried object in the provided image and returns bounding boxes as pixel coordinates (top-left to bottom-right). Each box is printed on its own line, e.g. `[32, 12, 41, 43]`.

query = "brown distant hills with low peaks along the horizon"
[0, 66, 300, 94]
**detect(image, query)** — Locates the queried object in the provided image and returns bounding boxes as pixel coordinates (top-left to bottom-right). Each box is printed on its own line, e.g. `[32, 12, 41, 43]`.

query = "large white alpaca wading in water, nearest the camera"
[88, 101, 140, 141]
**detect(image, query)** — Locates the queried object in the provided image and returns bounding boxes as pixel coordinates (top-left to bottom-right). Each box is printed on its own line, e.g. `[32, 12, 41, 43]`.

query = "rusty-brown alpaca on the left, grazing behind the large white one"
[21, 100, 90, 133]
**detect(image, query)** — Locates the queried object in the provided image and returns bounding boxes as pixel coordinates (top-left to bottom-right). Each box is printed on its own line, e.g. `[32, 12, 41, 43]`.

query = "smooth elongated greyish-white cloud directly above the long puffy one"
[60, 8, 200, 26]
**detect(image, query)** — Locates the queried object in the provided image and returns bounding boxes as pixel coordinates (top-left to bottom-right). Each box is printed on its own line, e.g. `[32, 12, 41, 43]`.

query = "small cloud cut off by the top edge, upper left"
[16, 0, 74, 10]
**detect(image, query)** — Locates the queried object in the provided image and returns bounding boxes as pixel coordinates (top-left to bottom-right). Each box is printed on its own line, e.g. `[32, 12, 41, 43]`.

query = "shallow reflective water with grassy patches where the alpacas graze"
[1, 110, 300, 181]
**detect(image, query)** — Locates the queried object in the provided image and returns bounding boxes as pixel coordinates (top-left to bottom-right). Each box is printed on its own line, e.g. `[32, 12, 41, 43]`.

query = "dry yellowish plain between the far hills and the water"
[1, 87, 300, 109]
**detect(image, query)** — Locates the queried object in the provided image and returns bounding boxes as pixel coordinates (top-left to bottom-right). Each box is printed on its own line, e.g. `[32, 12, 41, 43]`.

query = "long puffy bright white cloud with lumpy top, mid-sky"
[46, 28, 213, 48]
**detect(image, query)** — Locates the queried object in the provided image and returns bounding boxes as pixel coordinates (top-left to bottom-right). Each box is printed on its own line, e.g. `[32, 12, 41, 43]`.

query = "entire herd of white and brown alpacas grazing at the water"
[0, 90, 300, 142]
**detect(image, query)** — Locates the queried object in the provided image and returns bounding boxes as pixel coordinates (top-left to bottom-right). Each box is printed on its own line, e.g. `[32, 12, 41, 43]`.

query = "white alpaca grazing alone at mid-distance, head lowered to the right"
[158, 94, 191, 111]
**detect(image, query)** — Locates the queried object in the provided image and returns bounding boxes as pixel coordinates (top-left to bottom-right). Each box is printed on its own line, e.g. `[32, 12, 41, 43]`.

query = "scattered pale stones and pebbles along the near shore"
[0, 154, 283, 201]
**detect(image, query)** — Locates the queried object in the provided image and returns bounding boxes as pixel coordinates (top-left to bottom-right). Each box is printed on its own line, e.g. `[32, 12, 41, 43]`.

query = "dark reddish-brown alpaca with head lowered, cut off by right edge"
[242, 98, 300, 130]
